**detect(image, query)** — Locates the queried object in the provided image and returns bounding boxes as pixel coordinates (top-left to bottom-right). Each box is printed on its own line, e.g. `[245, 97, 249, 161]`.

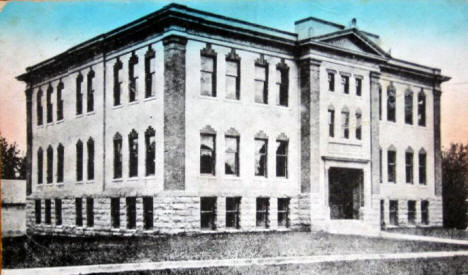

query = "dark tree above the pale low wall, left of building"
[0, 136, 26, 179]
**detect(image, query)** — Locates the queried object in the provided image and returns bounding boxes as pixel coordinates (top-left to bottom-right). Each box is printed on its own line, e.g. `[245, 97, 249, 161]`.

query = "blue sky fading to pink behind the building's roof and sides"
[0, 0, 468, 151]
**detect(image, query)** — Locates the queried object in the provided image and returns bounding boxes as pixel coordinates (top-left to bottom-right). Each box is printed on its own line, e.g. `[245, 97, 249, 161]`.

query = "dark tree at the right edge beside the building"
[442, 144, 468, 229]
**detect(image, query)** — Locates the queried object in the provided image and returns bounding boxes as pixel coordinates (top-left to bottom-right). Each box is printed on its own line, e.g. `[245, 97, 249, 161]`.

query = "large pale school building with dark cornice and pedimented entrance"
[18, 4, 449, 235]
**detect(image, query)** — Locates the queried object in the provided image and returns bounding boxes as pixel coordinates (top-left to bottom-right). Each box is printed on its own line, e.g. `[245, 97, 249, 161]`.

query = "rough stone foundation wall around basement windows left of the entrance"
[26, 194, 310, 236]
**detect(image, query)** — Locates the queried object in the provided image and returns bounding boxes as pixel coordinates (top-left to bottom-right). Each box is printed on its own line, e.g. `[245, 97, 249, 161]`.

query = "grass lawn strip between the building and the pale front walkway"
[2, 232, 468, 268]
